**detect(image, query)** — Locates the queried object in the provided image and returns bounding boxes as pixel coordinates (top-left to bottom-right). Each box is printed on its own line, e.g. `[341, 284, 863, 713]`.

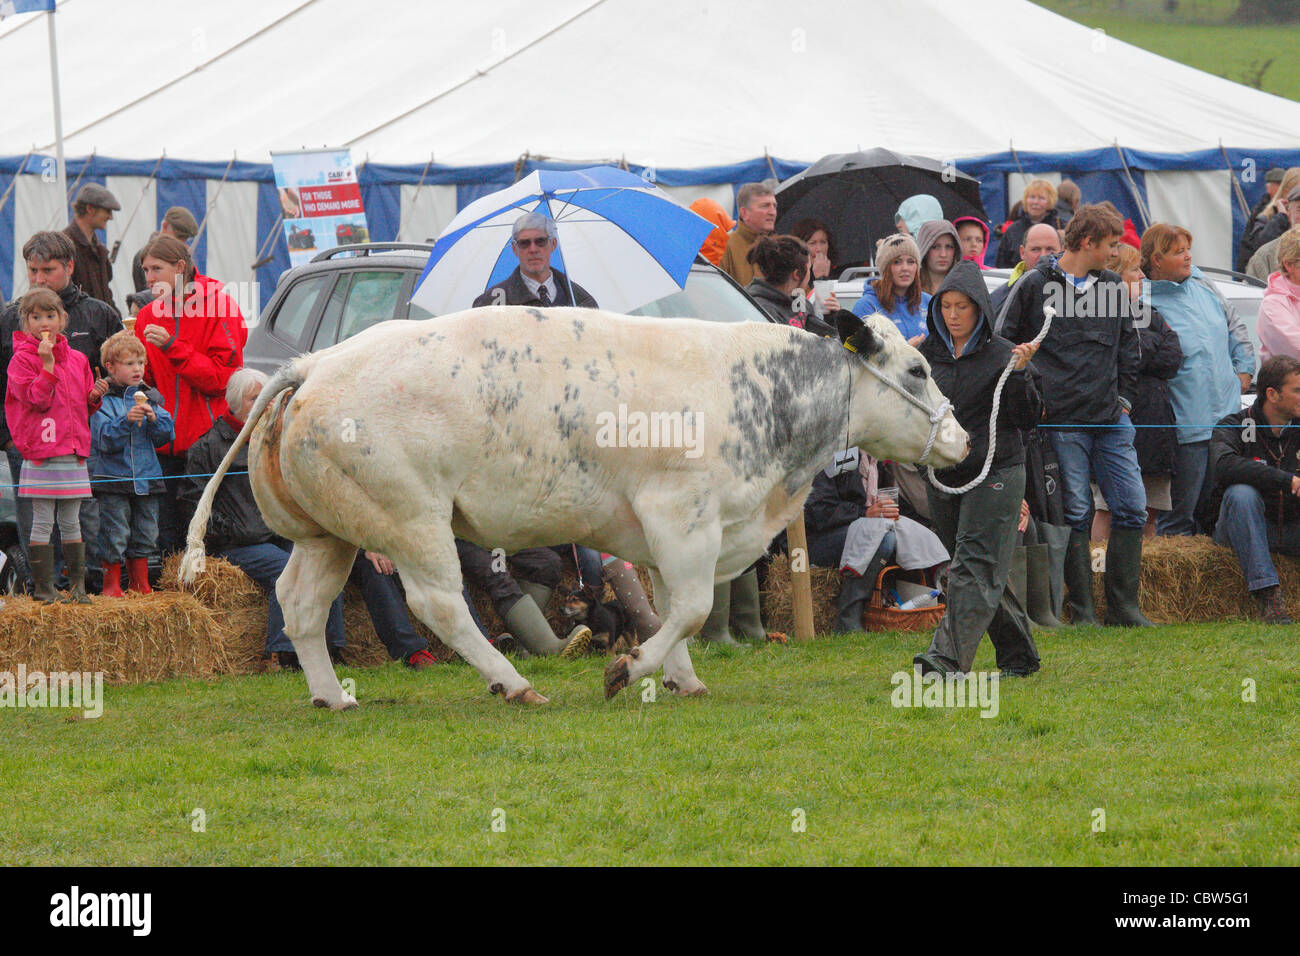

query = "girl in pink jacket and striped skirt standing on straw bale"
[4, 287, 108, 604]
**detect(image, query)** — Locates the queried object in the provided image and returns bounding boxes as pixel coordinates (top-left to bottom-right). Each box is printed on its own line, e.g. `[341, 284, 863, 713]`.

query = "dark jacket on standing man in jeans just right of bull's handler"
[1002, 256, 1141, 428]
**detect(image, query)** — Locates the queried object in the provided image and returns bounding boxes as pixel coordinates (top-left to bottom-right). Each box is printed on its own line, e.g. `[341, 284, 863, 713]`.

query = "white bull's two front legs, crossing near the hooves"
[605, 520, 722, 698]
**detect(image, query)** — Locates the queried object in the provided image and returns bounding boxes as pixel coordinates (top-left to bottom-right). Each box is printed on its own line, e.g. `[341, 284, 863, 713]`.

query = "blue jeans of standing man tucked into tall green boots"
[1047, 415, 1147, 533]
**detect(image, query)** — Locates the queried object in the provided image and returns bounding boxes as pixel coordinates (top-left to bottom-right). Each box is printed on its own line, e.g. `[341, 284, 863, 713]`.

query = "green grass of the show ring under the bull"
[0, 624, 1300, 865]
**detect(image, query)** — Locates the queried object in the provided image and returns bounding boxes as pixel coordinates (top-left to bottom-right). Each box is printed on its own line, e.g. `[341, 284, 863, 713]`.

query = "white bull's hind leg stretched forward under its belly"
[389, 523, 549, 704]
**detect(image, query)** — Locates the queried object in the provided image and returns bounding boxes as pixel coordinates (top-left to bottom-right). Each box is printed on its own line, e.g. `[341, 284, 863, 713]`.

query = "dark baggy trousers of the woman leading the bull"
[928, 464, 1039, 672]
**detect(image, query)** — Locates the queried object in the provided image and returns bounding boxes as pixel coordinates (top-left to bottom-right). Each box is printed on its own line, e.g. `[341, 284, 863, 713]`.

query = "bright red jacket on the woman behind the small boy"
[135, 274, 248, 458]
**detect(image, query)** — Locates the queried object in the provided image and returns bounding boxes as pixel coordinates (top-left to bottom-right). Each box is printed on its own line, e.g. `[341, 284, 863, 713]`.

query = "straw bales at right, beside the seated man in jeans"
[1093, 536, 1300, 624]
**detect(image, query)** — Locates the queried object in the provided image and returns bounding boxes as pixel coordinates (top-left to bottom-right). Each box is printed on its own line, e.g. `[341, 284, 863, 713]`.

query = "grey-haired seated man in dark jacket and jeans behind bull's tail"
[181, 368, 345, 667]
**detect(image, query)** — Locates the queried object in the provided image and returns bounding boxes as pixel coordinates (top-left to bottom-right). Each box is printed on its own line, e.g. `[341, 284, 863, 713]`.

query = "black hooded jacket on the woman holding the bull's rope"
[920, 260, 1043, 485]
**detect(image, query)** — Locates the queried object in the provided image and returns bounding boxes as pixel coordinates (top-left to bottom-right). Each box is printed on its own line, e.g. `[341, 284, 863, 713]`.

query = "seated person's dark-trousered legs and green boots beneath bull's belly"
[456, 538, 592, 657]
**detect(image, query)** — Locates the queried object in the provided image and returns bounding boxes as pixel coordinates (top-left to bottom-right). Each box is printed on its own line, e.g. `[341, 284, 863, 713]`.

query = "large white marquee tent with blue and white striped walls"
[0, 0, 1300, 312]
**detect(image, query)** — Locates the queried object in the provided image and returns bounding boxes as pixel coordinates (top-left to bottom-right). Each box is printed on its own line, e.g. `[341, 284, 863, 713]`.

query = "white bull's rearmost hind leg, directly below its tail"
[276, 536, 356, 710]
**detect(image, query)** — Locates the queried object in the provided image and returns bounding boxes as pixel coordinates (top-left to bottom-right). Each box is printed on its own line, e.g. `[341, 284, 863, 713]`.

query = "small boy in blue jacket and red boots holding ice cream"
[90, 332, 176, 597]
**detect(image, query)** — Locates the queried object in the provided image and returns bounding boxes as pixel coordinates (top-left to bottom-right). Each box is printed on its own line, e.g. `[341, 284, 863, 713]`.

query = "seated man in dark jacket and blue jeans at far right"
[1204, 355, 1300, 624]
